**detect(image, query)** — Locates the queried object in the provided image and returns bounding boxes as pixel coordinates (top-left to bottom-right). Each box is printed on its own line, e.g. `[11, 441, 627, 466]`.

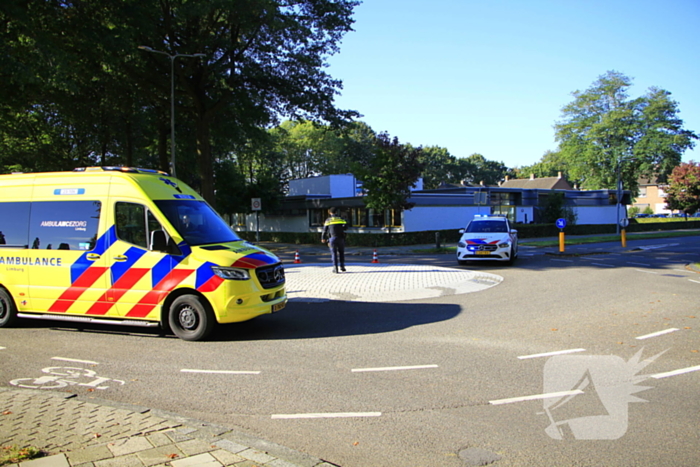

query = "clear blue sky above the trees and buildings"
[327, 0, 700, 167]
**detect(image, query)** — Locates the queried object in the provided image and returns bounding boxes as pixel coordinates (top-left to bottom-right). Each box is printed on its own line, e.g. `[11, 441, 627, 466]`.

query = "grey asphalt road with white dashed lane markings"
[0, 237, 700, 467]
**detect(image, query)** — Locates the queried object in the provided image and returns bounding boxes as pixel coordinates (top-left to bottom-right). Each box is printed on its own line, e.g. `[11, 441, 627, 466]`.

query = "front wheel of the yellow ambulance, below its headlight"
[168, 295, 216, 341]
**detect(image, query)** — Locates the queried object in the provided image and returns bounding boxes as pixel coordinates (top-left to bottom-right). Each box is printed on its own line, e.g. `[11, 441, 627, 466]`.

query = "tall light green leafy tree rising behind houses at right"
[555, 71, 697, 195]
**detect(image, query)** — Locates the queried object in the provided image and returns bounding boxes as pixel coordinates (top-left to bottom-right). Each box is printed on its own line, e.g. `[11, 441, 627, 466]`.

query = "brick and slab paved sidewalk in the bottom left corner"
[0, 388, 333, 467]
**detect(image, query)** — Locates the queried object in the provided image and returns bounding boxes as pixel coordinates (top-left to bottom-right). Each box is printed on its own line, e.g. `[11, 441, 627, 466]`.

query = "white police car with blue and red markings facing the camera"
[457, 215, 518, 264]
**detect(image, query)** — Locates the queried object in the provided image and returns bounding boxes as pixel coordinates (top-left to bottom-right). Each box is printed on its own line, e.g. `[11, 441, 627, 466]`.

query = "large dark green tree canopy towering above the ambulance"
[0, 0, 357, 208]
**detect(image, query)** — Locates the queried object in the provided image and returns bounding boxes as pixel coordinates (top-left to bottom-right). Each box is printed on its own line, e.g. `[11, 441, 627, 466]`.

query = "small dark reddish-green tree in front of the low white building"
[356, 133, 423, 211]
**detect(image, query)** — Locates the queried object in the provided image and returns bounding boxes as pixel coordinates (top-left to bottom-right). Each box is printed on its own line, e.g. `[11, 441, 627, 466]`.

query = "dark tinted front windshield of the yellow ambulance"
[155, 200, 241, 246]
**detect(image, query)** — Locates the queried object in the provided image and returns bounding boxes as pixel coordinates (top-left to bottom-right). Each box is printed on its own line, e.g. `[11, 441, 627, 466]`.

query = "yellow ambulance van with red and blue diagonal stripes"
[0, 167, 287, 341]
